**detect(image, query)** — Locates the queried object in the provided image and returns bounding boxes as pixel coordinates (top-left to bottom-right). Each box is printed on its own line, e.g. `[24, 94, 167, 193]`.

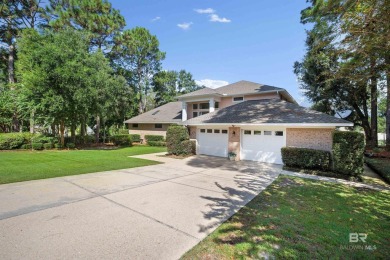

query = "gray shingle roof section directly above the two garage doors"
[183, 99, 350, 125]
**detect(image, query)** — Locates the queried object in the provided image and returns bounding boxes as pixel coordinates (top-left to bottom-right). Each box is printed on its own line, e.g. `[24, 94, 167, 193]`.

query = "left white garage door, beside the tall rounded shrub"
[198, 128, 228, 157]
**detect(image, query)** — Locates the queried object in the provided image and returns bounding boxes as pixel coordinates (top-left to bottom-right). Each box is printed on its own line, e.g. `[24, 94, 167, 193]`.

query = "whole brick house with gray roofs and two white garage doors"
[125, 81, 353, 164]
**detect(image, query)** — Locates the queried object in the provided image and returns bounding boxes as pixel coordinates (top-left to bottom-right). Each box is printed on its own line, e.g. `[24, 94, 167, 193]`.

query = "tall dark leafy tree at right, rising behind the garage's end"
[294, 0, 390, 146]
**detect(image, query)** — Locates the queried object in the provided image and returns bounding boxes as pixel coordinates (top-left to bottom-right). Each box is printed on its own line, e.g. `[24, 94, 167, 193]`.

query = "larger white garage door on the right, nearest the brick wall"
[241, 129, 286, 164]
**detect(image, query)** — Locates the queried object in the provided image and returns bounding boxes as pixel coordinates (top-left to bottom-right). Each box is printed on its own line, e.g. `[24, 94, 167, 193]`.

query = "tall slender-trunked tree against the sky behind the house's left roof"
[111, 27, 165, 113]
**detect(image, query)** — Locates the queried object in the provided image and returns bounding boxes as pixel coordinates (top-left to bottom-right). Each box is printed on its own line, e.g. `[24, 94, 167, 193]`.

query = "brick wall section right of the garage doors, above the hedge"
[286, 128, 334, 151]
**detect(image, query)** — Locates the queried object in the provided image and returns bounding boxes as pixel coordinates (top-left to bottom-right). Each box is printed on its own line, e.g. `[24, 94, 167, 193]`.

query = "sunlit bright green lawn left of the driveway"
[0, 146, 166, 184]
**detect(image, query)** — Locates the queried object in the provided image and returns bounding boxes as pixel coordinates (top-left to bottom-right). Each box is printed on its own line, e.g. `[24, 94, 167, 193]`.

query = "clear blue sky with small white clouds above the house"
[111, 0, 307, 105]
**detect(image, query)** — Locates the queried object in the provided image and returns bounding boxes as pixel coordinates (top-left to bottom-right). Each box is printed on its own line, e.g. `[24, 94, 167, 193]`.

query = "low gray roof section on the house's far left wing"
[125, 101, 182, 124]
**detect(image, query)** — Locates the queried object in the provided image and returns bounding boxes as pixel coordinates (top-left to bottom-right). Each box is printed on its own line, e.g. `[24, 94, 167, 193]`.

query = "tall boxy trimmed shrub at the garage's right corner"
[332, 131, 365, 177]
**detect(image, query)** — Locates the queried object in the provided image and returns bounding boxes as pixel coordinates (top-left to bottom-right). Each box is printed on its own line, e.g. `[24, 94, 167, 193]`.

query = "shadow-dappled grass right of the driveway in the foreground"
[183, 176, 390, 259]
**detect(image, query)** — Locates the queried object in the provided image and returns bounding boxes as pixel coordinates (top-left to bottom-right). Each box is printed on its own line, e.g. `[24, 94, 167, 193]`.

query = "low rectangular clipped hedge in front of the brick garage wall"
[282, 147, 331, 171]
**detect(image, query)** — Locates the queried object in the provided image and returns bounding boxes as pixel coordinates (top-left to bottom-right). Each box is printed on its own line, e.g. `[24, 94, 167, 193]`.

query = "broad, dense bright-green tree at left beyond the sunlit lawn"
[17, 30, 122, 144]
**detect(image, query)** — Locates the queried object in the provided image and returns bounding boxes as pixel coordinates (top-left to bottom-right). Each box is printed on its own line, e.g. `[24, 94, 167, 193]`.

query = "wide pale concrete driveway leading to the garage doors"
[0, 155, 281, 259]
